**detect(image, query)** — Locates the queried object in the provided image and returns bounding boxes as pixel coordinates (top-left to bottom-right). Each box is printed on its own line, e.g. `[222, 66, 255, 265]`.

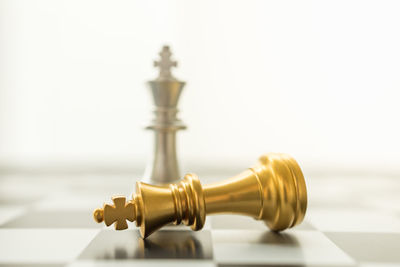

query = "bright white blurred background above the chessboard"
[0, 0, 400, 178]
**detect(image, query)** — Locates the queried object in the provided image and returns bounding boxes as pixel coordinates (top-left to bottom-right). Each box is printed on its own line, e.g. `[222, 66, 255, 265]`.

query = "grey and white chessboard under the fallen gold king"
[0, 173, 400, 267]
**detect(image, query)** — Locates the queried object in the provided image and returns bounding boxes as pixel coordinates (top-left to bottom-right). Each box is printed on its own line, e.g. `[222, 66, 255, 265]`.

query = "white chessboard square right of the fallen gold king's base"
[308, 208, 400, 233]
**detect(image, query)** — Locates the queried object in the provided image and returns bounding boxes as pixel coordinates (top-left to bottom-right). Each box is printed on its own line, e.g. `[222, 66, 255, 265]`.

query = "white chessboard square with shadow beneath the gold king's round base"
[212, 230, 354, 265]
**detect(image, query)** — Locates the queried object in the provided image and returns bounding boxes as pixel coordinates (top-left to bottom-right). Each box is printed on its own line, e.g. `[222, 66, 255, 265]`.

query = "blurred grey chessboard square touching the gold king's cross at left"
[1, 210, 102, 229]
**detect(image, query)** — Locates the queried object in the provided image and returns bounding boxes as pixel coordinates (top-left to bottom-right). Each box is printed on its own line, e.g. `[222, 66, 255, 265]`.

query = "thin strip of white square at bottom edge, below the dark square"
[67, 259, 216, 267]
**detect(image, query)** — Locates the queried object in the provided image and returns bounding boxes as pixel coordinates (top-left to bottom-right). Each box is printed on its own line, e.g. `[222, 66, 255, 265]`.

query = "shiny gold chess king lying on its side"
[93, 153, 307, 238]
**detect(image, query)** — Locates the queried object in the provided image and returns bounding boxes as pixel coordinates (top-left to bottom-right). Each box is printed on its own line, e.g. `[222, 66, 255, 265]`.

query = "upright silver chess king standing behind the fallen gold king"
[145, 46, 186, 184]
